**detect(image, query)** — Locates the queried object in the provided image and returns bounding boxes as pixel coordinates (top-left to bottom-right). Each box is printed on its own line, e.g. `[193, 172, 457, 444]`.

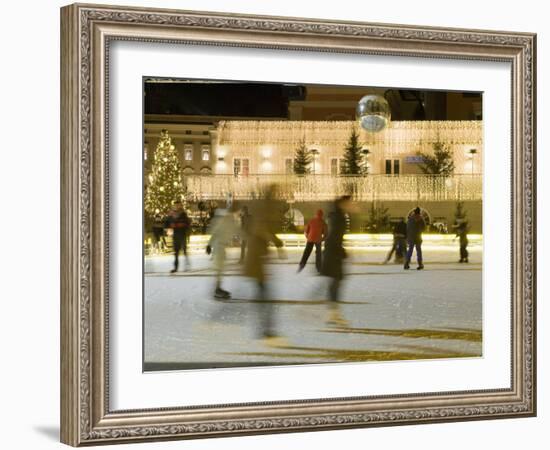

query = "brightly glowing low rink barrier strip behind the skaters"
[145, 233, 483, 254]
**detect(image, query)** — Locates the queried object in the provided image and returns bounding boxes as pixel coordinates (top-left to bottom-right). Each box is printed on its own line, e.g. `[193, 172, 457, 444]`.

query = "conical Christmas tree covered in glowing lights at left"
[145, 130, 185, 216]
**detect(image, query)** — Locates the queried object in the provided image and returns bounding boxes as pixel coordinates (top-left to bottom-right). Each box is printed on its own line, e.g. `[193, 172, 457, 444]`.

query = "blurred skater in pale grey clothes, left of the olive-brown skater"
[206, 206, 239, 299]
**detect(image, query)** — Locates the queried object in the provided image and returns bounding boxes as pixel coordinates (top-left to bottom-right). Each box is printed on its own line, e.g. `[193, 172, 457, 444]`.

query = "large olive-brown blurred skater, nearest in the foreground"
[244, 185, 283, 345]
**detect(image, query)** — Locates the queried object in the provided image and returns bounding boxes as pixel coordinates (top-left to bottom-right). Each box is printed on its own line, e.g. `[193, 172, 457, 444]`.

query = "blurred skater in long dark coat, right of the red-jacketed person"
[321, 195, 351, 326]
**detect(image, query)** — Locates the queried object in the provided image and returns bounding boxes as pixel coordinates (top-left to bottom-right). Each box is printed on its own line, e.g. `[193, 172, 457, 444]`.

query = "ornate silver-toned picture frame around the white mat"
[61, 4, 536, 446]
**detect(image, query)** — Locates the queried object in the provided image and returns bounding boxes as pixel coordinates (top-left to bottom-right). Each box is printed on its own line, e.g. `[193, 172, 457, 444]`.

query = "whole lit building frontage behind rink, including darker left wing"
[144, 119, 483, 232]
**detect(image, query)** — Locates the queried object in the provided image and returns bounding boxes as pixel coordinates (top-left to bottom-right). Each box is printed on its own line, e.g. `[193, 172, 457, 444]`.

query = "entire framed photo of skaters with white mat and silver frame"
[61, 4, 536, 446]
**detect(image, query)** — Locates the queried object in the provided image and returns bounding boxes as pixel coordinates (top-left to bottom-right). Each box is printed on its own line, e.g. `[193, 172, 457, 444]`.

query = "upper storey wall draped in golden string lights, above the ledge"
[212, 121, 483, 176]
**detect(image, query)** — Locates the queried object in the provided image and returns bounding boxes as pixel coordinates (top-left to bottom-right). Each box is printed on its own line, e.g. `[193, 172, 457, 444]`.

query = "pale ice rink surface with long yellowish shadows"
[144, 248, 482, 370]
